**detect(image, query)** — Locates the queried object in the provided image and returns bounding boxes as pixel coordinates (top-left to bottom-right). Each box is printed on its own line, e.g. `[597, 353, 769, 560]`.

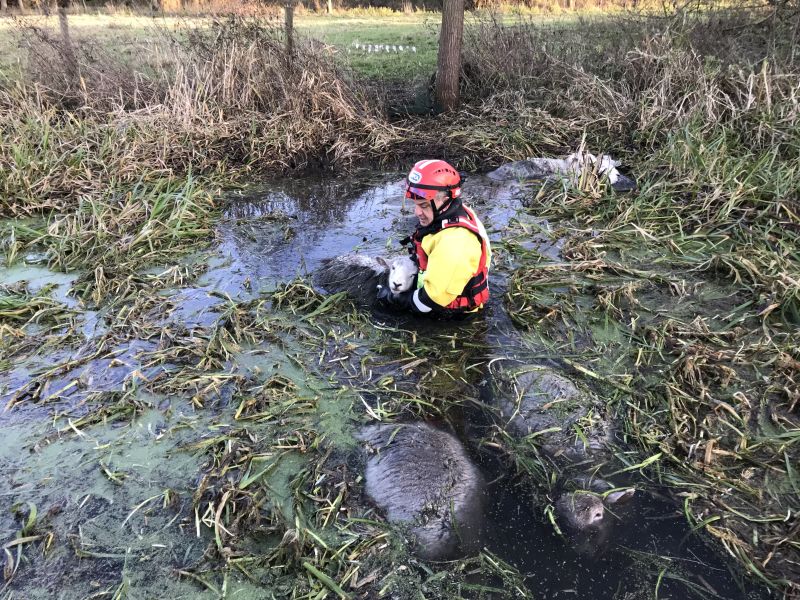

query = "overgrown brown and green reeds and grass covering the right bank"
[454, 8, 800, 596]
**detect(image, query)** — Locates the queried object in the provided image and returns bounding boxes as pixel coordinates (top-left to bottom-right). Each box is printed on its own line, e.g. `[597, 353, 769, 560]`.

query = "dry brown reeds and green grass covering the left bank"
[0, 19, 399, 300]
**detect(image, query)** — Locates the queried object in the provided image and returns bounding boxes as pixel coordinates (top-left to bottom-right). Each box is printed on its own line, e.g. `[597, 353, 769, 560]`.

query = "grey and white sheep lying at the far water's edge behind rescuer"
[488, 153, 636, 192]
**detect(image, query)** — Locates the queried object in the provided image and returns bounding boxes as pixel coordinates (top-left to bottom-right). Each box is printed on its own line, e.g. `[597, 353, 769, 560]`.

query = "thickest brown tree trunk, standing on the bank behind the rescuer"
[436, 0, 464, 112]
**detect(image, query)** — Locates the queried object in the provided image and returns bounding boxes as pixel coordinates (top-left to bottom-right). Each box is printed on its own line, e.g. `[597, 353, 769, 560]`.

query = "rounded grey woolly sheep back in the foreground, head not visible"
[356, 423, 485, 560]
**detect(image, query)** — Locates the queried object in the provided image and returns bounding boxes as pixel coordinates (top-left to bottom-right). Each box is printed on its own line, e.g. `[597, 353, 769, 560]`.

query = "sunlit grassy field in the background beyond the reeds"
[0, 10, 603, 79]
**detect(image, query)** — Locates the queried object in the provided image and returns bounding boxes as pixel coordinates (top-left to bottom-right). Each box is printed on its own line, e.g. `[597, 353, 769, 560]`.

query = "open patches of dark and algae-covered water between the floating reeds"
[0, 175, 768, 599]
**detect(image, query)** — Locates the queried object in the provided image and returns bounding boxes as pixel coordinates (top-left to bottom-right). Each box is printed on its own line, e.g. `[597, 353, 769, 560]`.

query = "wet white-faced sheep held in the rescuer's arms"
[313, 254, 419, 306]
